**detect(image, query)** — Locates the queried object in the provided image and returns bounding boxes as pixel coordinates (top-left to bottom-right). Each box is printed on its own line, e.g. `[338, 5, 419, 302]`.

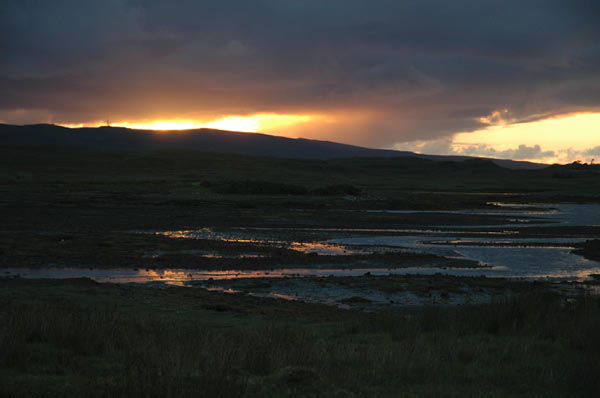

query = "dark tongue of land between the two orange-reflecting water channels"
[0, 231, 479, 270]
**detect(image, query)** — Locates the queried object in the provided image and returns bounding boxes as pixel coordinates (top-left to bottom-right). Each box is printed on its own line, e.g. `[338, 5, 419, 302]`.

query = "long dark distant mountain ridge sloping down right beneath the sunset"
[0, 124, 547, 169]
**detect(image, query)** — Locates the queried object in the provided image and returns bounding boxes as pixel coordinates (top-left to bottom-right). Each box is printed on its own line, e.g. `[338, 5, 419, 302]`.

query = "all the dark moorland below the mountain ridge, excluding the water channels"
[0, 136, 600, 397]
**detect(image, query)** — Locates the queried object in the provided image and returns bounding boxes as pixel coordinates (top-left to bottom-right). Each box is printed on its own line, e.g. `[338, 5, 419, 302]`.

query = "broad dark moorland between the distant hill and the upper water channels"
[0, 146, 600, 233]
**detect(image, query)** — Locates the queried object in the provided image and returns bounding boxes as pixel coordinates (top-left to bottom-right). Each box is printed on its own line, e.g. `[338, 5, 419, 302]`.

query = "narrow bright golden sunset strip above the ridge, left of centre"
[62, 113, 317, 133]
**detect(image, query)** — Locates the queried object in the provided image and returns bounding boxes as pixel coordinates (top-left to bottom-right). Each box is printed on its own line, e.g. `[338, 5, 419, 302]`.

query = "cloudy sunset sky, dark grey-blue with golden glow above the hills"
[0, 0, 600, 163]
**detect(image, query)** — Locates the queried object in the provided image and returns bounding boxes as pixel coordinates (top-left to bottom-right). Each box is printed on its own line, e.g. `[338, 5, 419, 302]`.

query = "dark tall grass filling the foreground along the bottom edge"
[0, 294, 600, 397]
